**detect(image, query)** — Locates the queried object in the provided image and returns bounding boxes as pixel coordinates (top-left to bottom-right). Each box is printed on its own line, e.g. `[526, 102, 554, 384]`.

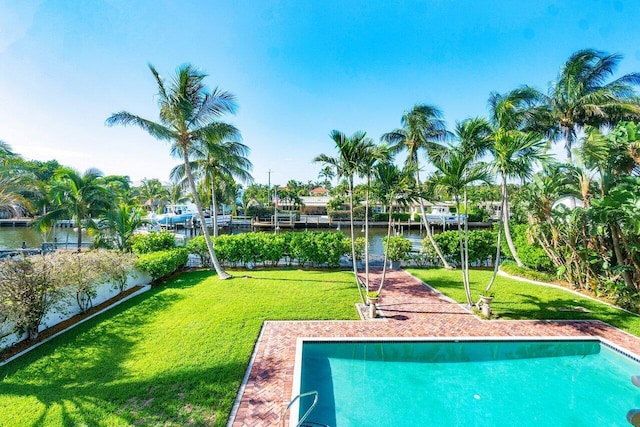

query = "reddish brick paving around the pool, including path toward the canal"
[229, 271, 640, 427]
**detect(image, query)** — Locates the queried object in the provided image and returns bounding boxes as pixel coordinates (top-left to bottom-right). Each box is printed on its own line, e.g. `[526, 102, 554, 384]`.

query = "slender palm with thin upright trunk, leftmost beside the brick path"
[313, 130, 372, 304]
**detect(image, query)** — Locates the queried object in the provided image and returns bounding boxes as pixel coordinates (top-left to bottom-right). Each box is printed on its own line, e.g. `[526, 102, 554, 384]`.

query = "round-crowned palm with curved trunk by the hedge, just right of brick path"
[381, 104, 452, 269]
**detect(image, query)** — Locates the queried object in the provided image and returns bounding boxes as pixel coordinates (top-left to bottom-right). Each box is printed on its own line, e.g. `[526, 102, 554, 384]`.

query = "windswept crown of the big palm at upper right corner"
[537, 49, 640, 163]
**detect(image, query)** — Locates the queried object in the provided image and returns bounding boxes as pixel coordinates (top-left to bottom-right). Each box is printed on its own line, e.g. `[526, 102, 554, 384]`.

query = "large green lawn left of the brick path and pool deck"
[0, 270, 358, 426]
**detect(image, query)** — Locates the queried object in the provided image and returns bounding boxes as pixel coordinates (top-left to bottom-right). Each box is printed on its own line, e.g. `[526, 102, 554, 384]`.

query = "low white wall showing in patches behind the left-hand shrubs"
[0, 270, 151, 350]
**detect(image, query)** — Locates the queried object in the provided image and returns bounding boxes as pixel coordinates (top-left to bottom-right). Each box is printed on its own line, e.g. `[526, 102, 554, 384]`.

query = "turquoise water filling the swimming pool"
[299, 341, 640, 427]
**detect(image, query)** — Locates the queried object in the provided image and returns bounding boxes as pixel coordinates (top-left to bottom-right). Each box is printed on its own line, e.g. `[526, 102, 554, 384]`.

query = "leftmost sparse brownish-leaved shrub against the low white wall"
[0, 254, 65, 339]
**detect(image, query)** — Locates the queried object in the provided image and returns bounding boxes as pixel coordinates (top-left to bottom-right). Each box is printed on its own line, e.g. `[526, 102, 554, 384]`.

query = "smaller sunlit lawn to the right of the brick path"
[407, 268, 640, 336]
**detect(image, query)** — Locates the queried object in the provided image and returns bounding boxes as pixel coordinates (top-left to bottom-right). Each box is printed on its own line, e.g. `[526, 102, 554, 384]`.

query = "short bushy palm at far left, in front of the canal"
[39, 168, 115, 252]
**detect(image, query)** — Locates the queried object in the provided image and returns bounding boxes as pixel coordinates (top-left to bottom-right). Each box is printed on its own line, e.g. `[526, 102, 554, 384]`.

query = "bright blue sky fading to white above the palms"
[0, 0, 640, 184]
